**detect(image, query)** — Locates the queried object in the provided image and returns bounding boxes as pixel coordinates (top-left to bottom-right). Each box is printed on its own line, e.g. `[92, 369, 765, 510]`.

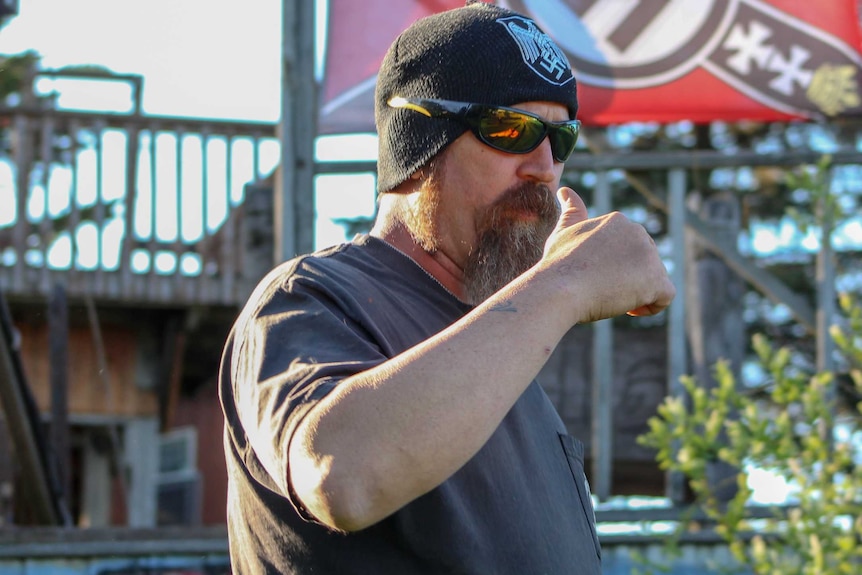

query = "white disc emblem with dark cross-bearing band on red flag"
[497, 0, 862, 116]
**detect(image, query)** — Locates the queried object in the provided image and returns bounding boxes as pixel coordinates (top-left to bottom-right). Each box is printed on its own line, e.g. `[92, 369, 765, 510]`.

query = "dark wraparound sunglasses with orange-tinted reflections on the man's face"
[388, 96, 581, 162]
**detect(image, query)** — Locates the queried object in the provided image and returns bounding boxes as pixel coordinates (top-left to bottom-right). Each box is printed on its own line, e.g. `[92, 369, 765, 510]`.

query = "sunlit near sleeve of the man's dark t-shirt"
[231, 272, 387, 510]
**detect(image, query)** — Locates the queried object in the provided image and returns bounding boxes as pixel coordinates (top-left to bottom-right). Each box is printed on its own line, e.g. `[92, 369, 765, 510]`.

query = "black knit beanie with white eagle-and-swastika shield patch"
[374, 2, 578, 193]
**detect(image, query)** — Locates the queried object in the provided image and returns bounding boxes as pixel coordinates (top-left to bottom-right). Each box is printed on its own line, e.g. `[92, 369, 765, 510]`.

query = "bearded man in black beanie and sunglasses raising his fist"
[220, 2, 674, 575]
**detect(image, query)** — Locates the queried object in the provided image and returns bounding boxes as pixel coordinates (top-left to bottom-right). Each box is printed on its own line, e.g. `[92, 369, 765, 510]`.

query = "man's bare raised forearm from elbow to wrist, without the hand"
[290, 266, 572, 530]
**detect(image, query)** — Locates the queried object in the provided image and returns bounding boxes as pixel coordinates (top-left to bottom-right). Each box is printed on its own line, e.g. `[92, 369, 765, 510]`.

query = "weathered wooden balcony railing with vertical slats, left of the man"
[0, 106, 278, 305]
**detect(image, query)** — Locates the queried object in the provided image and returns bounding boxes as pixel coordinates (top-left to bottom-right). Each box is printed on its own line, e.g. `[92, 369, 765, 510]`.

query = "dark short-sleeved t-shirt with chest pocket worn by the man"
[220, 236, 601, 575]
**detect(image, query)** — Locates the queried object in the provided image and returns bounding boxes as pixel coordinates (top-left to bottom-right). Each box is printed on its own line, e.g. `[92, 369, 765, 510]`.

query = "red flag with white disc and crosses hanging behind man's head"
[319, 0, 862, 134]
